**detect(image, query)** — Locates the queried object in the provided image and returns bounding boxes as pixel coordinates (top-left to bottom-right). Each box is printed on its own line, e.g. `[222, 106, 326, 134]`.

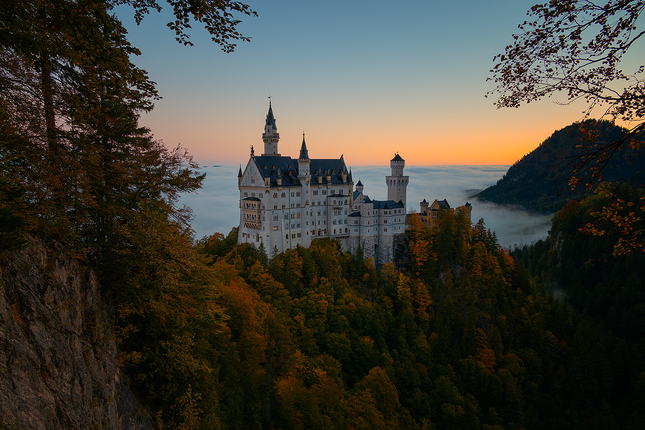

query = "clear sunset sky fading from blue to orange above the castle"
[116, 0, 612, 166]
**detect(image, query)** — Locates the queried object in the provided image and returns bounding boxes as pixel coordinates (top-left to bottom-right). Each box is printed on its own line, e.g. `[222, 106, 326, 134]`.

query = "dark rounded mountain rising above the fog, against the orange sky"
[476, 120, 645, 213]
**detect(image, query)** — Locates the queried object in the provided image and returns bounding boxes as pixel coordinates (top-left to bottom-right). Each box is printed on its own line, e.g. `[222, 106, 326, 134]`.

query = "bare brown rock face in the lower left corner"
[0, 239, 151, 429]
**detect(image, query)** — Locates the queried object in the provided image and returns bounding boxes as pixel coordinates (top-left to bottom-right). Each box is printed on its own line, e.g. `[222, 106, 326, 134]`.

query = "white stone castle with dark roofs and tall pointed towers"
[238, 102, 409, 265]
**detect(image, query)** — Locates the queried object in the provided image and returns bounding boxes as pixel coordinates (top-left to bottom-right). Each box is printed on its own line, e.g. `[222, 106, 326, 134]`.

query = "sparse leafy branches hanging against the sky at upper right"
[487, 0, 645, 182]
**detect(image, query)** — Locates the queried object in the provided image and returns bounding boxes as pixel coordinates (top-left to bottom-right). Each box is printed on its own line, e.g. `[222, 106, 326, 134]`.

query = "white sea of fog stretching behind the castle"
[180, 165, 551, 247]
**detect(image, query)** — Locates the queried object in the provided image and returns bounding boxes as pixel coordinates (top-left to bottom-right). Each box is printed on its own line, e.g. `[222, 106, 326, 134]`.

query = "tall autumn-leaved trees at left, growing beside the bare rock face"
[0, 0, 257, 429]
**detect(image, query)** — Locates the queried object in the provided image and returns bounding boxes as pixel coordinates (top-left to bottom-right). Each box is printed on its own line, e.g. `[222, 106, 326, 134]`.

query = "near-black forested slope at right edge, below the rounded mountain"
[514, 186, 645, 341]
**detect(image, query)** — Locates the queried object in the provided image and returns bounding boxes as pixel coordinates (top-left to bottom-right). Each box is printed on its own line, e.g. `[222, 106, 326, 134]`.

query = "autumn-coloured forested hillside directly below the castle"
[113, 207, 645, 429]
